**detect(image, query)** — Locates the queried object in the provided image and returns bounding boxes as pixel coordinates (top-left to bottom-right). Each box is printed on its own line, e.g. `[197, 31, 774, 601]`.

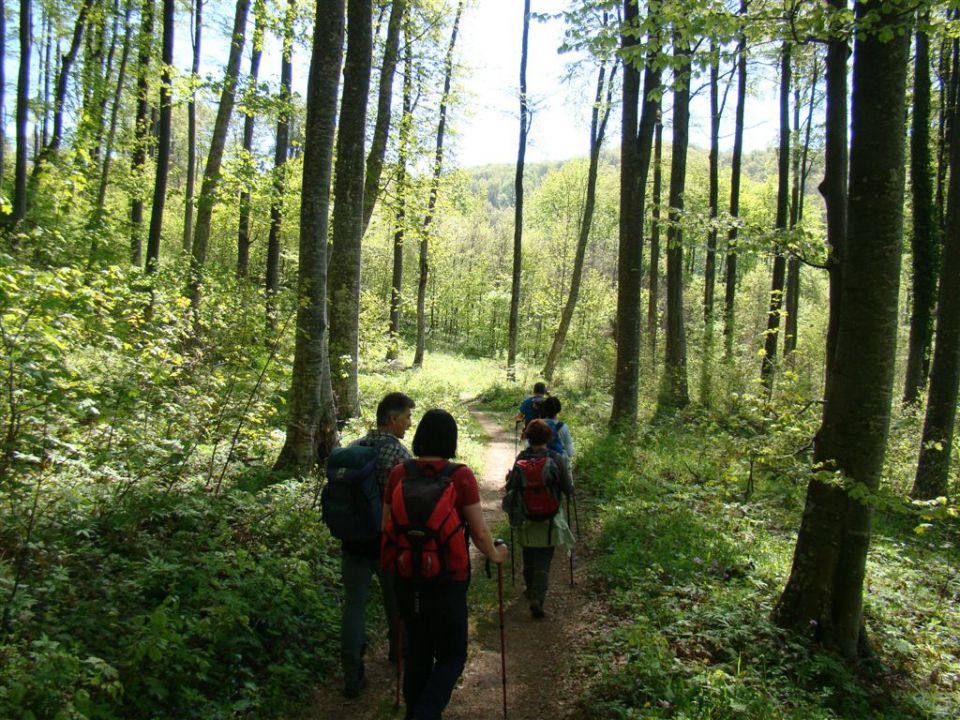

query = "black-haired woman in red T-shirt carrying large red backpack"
[381, 410, 507, 720]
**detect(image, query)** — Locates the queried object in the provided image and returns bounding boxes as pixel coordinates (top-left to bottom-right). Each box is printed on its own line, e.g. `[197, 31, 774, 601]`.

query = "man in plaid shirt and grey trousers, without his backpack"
[340, 392, 414, 698]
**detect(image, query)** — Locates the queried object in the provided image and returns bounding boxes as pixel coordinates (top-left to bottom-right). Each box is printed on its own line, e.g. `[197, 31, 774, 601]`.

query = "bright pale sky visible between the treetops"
[452, 0, 778, 167]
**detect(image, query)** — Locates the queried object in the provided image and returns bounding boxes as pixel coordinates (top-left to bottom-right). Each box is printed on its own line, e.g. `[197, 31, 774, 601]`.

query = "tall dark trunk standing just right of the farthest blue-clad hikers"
[610, 0, 661, 427]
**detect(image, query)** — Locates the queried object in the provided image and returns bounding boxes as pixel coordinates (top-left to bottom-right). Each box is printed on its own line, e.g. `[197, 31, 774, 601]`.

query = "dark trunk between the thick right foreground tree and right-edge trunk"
[903, 19, 940, 404]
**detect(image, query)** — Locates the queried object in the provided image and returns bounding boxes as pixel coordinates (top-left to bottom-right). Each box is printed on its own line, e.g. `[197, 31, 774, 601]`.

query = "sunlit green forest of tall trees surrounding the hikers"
[0, 0, 960, 720]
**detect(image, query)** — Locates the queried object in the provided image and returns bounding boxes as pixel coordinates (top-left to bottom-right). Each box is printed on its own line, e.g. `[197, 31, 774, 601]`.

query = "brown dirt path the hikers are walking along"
[305, 413, 596, 720]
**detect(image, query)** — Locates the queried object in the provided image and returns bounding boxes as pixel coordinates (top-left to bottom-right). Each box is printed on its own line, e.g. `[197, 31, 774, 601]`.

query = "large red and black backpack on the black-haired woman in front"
[380, 460, 470, 580]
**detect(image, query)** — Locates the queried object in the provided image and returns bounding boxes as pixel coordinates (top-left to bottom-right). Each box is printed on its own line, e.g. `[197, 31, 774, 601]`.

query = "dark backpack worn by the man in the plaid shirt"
[320, 440, 391, 542]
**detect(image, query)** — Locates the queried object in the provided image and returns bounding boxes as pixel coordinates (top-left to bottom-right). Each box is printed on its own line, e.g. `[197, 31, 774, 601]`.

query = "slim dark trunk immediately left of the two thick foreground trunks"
[265, 0, 297, 330]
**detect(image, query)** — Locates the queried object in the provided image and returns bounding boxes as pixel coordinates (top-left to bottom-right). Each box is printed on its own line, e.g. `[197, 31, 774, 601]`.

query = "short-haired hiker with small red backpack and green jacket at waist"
[503, 419, 573, 619]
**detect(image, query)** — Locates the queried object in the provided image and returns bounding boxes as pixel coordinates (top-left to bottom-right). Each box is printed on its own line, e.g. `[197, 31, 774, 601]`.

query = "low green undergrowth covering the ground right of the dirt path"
[570, 400, 960, 720]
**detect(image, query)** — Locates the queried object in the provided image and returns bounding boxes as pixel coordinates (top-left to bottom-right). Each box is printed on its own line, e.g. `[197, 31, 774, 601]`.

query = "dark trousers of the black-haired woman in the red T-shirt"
[397, 578, 469, 720]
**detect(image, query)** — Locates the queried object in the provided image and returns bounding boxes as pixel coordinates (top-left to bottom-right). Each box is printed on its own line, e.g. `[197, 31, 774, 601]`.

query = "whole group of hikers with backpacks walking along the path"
[321, 383, 574, 720]
